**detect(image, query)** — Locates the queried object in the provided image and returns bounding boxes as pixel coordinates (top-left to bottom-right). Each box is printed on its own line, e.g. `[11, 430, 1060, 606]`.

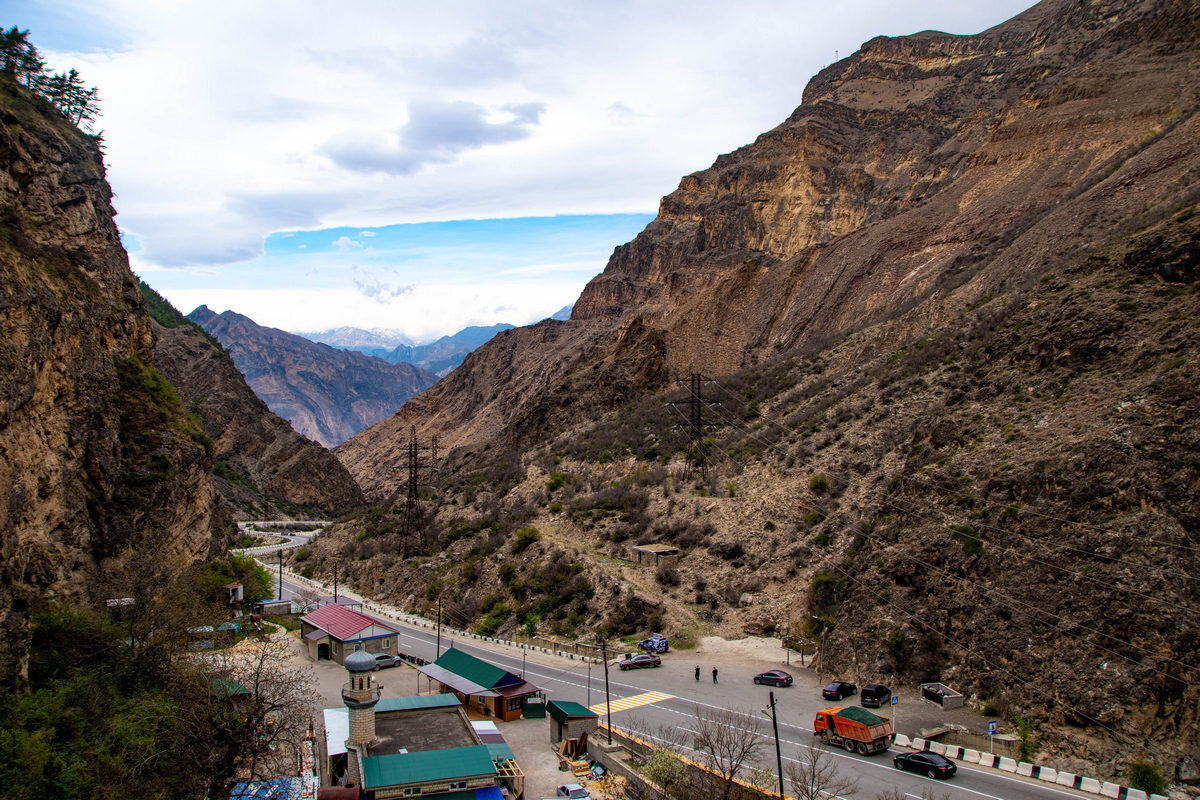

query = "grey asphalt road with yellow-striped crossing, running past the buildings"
[276, 577, 1094, 800]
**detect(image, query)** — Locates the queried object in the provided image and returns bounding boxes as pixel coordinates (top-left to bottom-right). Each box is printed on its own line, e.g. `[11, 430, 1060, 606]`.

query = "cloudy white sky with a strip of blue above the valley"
[7, 0, 1032, 342]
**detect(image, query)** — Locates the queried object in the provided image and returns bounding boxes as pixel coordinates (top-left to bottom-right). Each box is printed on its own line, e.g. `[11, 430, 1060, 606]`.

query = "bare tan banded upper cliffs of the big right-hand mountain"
[572, 0, 1200, 373]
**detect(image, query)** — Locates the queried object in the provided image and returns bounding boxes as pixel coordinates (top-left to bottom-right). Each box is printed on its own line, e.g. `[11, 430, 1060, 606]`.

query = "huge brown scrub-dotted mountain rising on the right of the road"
[324, 0, 1200, 777]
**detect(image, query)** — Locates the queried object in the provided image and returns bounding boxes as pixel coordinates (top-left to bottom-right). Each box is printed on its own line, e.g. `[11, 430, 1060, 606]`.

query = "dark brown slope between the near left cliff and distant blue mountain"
[155, 323, 364, 518]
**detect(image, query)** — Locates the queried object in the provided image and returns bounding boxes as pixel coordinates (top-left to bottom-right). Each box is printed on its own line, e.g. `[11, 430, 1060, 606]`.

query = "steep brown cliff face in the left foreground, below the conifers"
[0, 76, 228, 656]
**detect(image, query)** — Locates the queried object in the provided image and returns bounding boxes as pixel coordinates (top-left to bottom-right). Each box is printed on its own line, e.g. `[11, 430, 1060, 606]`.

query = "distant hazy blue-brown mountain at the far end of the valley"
[187, 306, 437, 447]
